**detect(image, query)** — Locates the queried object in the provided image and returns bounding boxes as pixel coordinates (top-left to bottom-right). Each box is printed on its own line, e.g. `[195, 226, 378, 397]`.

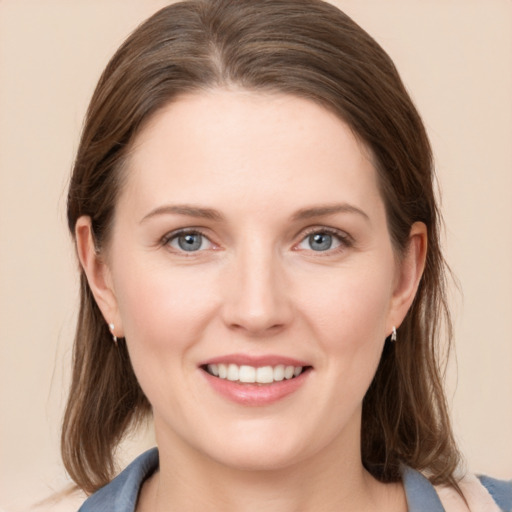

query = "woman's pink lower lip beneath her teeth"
[201, 369, 311, 406]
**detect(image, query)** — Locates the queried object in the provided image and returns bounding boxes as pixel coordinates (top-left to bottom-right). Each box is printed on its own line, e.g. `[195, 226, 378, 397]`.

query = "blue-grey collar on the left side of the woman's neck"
[79, 448, 158, 512]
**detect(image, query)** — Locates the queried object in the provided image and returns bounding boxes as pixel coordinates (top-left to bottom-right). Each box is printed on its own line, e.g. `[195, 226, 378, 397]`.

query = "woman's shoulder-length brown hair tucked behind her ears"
[62, 0, 459, 492]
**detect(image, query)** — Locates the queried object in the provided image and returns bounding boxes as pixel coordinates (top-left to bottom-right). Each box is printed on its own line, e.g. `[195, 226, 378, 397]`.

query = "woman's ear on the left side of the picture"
[75, 216, 124, 338]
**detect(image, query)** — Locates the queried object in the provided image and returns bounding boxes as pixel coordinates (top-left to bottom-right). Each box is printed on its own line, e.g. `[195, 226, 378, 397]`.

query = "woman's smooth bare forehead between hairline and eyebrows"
[121, 89, 380, 220]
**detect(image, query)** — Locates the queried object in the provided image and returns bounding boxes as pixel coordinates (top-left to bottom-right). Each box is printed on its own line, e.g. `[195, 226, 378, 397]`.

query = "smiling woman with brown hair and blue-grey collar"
[62, 0, 512, 511]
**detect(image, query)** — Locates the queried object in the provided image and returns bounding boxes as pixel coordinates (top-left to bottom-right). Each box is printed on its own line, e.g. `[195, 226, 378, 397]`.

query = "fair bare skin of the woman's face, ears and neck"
[76, 89, 427, 512]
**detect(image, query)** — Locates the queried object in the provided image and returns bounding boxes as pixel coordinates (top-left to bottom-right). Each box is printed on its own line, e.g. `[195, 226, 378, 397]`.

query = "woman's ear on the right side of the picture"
[389, 222, 428, 332]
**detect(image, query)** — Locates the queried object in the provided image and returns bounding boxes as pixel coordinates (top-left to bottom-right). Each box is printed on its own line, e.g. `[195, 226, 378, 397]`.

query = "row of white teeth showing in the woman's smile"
[201, 363, 311, 384]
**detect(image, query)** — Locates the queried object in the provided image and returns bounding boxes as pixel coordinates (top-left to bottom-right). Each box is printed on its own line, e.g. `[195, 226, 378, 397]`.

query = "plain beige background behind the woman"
[0, 0, 512, 511]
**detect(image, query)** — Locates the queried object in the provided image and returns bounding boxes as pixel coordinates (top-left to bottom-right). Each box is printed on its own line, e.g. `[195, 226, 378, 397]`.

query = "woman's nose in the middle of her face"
[223, 240, 293, 337]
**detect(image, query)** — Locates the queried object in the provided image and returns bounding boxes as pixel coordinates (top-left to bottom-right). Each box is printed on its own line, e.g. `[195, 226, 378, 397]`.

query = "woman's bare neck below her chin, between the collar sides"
[137, 422, 407, 512]
